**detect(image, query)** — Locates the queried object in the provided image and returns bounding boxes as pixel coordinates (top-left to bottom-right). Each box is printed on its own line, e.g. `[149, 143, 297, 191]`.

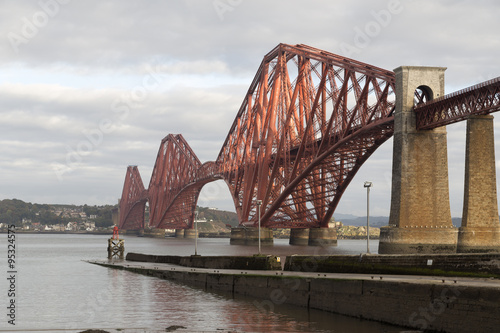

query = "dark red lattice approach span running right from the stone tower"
[414, 77, 500, 129]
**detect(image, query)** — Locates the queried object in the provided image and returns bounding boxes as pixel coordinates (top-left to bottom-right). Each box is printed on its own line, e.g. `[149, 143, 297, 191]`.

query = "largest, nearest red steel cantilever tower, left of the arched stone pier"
[216, 44, 395, 227]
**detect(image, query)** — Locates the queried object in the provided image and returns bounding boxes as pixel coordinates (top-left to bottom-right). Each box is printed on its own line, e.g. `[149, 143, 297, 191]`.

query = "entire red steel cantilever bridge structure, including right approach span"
[119, 44, 500, 230]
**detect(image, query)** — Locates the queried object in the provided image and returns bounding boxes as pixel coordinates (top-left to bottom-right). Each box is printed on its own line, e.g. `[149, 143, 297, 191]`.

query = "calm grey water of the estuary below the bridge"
[0, 234, 402, 333]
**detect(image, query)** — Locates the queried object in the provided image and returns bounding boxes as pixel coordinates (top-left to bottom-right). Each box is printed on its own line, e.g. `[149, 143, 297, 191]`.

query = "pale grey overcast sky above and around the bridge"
[0, 0, 500, 217]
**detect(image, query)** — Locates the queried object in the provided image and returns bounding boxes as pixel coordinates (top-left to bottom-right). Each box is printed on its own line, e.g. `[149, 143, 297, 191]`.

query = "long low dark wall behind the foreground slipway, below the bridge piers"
[126, 252, 500, 278]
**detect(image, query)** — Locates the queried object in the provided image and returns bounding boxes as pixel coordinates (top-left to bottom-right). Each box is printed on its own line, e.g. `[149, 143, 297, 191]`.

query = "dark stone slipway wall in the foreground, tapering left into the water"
[96, 263, 500, 333]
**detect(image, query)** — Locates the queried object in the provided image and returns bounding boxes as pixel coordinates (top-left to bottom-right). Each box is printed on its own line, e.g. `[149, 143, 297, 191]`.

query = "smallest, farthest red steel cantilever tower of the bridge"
[118, 166, 148, 230]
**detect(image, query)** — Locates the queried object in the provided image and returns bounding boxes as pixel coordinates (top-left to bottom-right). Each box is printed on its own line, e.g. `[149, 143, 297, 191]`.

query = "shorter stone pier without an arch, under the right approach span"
[457, 115, 500, 253]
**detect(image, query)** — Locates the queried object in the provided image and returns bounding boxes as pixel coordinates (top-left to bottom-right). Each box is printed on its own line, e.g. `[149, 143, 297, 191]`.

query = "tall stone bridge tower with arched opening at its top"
[379, 67, 458, 253]
